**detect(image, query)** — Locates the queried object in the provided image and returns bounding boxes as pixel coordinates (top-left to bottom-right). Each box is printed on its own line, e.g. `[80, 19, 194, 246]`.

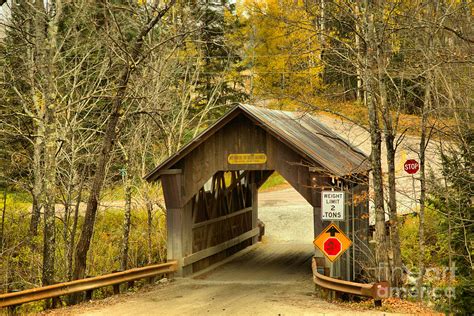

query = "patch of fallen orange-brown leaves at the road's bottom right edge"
[338, 297, 444, 315]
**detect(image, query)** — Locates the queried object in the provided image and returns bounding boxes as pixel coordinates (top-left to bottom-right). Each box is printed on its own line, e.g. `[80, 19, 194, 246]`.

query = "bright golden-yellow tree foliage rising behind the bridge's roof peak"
[245, 0, 322, 96]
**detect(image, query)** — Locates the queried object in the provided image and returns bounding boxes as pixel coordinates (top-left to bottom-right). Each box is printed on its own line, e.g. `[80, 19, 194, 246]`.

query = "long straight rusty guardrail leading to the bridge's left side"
[0, 261, 178, 308]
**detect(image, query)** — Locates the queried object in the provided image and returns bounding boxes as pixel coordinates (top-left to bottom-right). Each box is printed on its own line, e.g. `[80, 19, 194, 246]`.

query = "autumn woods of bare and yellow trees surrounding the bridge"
[0, 0, 474, 313]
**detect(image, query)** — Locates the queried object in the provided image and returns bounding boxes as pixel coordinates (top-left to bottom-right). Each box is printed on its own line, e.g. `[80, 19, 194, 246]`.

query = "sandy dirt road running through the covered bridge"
[42, 188, 438, 315]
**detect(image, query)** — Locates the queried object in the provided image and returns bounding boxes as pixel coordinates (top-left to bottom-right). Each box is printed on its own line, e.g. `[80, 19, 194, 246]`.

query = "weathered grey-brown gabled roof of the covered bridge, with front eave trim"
[145, 104, 370, 181]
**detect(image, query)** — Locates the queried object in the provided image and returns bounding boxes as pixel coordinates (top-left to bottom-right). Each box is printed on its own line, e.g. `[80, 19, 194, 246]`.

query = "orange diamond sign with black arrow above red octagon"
[313, 224, 352, 262]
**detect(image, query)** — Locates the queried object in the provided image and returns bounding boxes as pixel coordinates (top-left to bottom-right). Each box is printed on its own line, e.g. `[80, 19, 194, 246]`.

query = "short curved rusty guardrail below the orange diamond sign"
[311, 257, 389, 305]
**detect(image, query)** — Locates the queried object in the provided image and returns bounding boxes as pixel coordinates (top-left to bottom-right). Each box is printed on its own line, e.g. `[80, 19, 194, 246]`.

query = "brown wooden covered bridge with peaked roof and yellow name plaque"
[146, 105, 370, 280]
